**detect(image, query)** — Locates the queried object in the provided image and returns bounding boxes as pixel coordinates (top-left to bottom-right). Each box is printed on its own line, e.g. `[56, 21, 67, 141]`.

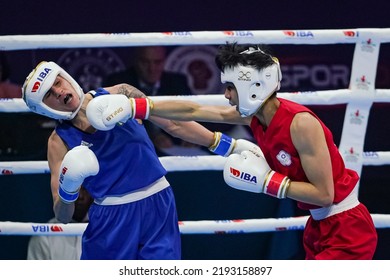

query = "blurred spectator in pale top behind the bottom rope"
[27, 188, 93, 260]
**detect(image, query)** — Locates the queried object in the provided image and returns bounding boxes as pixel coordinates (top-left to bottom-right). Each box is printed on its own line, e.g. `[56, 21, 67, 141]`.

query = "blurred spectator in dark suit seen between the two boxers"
[103, 46, 209, 156]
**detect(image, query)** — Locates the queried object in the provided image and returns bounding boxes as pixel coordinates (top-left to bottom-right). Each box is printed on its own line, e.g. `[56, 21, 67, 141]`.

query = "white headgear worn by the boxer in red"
[221, 57, 282, 117]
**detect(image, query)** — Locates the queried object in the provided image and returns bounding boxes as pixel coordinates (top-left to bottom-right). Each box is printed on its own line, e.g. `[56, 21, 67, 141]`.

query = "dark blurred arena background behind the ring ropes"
[0, 0, 390, 259]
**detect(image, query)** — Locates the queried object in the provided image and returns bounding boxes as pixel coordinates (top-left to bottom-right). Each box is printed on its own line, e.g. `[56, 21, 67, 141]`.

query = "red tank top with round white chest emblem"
[250, 98, 359, 210]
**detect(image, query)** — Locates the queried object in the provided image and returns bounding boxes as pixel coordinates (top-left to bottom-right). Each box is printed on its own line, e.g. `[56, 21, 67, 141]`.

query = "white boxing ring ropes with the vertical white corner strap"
[0, 28, 390, 235]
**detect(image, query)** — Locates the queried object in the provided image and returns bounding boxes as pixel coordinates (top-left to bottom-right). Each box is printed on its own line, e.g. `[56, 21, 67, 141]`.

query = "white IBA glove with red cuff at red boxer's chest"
[223, 151, 291, 198]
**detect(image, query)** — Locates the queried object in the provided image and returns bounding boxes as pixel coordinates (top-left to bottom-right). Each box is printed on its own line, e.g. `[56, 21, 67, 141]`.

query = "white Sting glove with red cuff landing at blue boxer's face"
[86, 94, 152, 131]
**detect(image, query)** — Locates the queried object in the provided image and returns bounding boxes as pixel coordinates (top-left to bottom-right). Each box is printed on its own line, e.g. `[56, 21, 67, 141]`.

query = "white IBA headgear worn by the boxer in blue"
[22, 61, 84, 120]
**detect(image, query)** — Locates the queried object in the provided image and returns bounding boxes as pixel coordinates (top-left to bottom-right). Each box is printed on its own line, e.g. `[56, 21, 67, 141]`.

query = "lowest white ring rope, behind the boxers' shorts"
[0, 214, 390, 236]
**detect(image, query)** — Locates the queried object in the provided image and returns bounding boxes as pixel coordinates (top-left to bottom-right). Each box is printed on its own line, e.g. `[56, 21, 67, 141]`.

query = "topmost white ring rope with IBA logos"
[0, 28, 390, 50]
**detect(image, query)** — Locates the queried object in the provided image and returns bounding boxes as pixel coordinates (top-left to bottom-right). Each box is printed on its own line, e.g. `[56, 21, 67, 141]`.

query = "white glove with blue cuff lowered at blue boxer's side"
[58, 146, 99, 203]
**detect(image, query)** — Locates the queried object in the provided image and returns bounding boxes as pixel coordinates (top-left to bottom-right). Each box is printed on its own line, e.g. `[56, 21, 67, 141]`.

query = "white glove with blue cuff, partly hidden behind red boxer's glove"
[209, 132, 264, 157]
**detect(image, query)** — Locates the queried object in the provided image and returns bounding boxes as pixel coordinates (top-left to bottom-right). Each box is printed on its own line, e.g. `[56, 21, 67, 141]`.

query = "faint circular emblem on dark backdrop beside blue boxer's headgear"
[58, 48, 125, 91]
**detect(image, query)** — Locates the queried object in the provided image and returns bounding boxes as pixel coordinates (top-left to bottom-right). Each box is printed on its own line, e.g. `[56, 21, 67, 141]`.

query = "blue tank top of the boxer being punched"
[56, 88, 167, 198]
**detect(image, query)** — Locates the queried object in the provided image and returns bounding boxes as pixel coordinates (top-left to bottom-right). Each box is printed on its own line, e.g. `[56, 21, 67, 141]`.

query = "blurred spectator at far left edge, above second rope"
[0, 51, 22, 98]
